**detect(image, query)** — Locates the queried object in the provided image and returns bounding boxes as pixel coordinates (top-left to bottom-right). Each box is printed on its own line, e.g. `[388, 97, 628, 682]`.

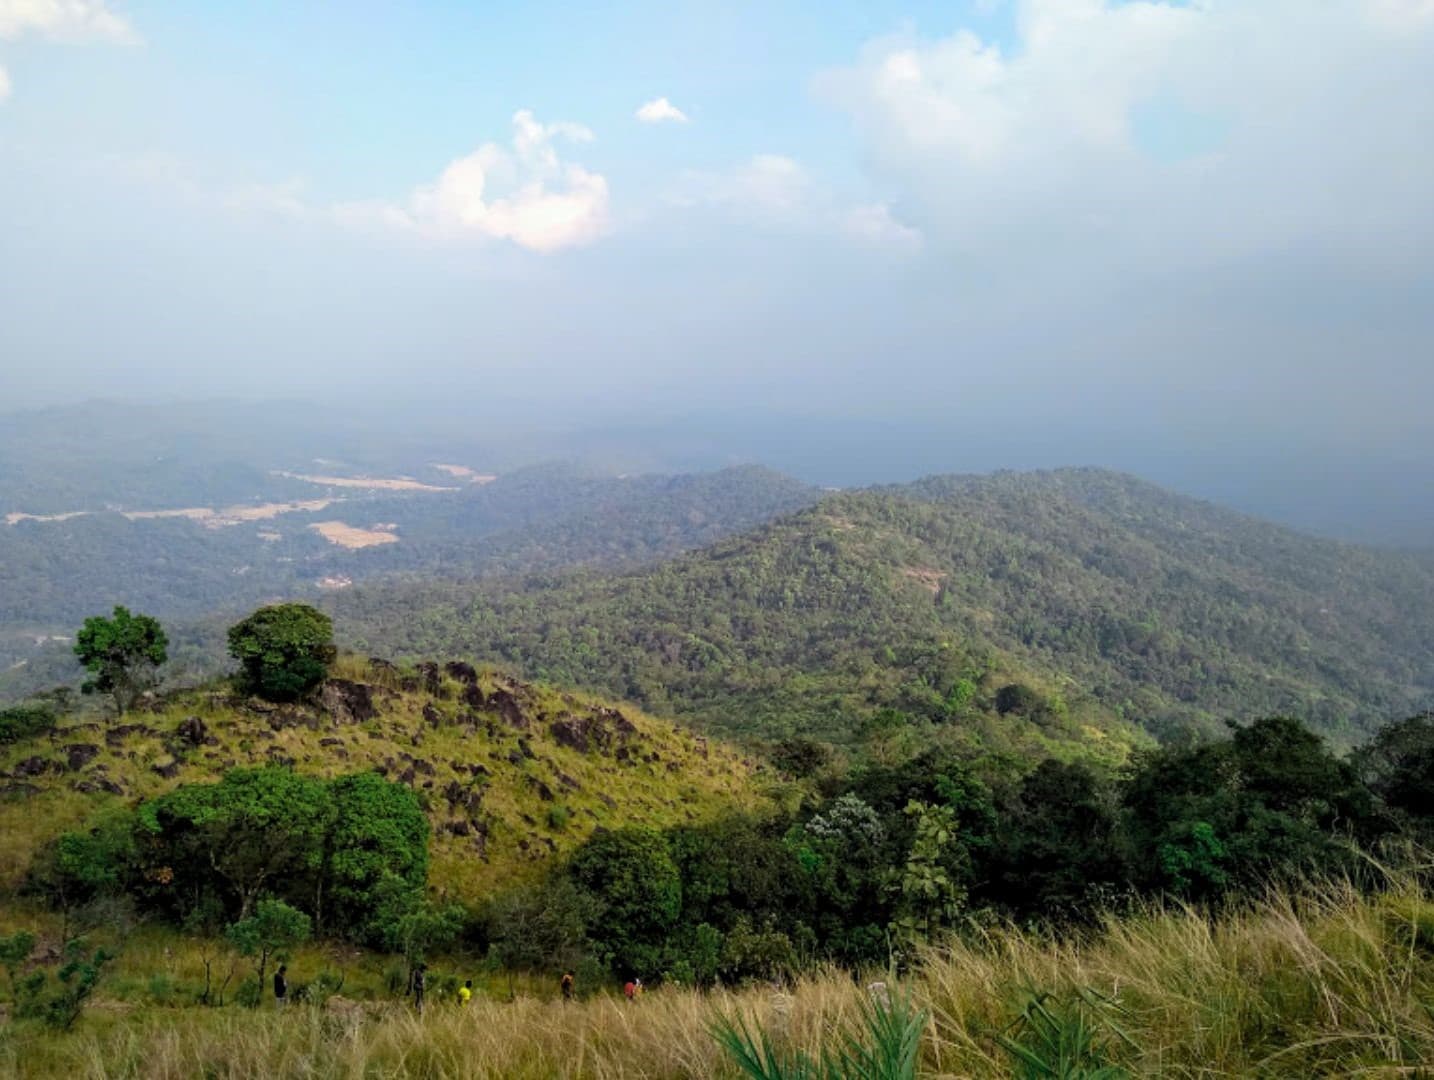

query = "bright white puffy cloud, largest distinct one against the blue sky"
[334, 109, 611, 252]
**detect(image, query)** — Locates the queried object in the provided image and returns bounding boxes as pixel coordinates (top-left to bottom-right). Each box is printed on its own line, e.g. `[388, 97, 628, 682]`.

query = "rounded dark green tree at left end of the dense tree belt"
[569, 828, 683, 971]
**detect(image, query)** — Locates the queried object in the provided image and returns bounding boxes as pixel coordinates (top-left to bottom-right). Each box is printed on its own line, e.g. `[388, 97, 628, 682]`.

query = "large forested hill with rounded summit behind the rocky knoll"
[336, 470, 1434, 739]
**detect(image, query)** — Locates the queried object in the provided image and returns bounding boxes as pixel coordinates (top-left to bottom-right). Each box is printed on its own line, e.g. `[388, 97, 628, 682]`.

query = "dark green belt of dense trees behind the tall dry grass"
[476, 717, 1416, 985]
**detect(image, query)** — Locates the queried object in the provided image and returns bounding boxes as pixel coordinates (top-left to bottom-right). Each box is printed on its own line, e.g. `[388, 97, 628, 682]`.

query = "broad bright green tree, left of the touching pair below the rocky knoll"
[139, 766, 333, 919]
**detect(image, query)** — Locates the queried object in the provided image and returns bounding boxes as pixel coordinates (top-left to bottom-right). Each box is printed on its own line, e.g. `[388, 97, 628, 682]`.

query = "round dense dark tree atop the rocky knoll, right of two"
[229, 604, 336, 701]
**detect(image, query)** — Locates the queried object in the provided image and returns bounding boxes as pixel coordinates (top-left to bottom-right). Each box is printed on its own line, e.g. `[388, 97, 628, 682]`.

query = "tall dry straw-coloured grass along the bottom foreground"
[0, 885, 1434, 1080]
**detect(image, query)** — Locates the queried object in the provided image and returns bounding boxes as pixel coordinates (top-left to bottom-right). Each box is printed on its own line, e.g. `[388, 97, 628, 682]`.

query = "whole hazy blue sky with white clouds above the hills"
[0, 0, 1434, 493]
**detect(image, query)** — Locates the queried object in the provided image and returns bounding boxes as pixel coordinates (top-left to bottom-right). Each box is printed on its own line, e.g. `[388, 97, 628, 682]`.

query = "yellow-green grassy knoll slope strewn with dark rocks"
[0, 658, 774, 899]
